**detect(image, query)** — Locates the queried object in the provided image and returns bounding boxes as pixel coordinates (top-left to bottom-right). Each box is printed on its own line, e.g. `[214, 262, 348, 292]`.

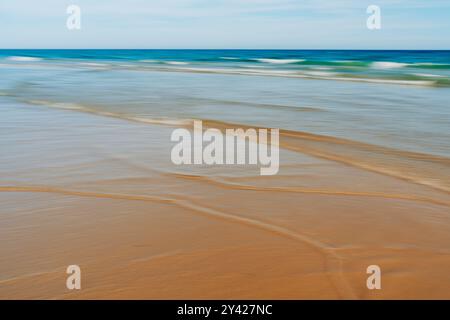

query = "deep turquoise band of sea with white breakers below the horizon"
[0, 50, 450, 86]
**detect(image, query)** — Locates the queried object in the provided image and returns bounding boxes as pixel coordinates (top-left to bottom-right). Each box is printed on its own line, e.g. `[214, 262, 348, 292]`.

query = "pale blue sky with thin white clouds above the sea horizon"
[0, 0, 450, 49]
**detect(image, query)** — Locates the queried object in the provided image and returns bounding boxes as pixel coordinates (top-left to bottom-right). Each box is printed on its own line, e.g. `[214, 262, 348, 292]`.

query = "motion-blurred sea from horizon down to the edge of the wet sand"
[0, 50, 450, 157]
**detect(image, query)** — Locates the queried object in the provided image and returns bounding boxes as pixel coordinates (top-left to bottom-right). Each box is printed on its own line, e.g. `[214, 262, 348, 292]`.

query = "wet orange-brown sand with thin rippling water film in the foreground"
[0, 103, 450, 299]
